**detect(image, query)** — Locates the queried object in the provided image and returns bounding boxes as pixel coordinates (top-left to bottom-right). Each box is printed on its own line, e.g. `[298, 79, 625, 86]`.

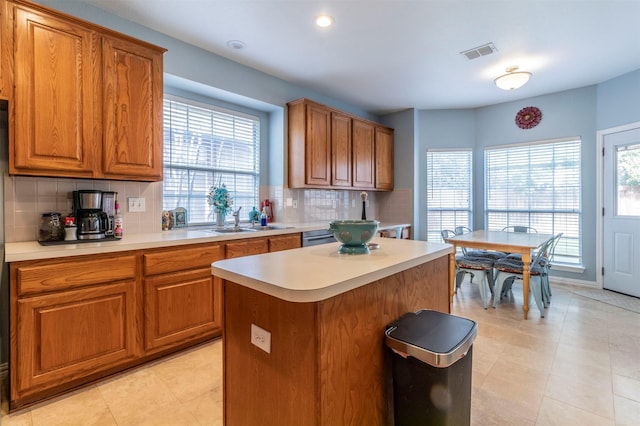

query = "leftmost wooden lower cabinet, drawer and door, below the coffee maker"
[10, 255, 142, 407]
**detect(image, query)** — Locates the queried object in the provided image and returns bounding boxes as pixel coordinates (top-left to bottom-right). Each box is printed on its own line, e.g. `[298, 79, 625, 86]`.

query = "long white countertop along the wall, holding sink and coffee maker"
[5, 221, 410, 262]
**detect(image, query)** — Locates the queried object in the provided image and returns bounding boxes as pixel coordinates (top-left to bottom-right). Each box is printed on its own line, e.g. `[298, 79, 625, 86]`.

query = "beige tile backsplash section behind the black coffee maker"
[4, 174, 162, 242]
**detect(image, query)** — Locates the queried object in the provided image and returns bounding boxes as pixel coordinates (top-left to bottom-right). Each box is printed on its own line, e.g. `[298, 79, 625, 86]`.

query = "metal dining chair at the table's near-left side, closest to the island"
[440, 229, 495, 309]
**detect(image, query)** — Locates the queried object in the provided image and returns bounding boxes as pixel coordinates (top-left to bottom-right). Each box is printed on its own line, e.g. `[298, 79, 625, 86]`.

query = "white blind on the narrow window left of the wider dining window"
[427, 150, 473, 241]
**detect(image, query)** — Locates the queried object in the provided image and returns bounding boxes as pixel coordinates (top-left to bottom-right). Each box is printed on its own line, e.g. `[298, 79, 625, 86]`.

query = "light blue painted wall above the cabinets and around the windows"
[37, 0, 640, 281]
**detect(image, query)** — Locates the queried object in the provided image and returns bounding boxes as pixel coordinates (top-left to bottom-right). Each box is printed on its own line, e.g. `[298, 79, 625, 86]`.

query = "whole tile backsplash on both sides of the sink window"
[4, 174, 412, 242]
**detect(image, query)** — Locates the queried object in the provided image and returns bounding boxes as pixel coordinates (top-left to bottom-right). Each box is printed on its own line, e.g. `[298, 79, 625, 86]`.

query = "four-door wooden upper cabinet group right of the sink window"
[287, 99, 393, 191]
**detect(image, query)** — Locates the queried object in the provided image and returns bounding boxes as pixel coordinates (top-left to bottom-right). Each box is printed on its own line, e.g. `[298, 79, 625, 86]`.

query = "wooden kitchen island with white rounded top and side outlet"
[212, 238, 452, 425]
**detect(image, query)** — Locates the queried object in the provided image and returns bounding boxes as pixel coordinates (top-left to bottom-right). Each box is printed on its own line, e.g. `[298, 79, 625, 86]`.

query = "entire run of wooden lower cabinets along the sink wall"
[9, 233, 301, 410]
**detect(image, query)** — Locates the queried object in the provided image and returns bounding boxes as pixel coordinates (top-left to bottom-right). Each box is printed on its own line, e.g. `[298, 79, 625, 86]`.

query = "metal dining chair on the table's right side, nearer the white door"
[493, 238, 554, 318]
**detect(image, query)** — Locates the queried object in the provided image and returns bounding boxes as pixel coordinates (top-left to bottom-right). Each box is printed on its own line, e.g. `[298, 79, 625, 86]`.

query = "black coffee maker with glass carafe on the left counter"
[73, 189, 109, 240]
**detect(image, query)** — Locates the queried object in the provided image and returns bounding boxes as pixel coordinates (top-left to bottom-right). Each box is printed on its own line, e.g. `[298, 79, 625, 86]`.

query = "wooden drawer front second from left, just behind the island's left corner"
[142, 244, 224, 275]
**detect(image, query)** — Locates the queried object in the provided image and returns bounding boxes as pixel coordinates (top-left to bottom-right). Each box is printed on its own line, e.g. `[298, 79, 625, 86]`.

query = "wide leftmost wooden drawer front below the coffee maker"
[11, 254, 136, 296]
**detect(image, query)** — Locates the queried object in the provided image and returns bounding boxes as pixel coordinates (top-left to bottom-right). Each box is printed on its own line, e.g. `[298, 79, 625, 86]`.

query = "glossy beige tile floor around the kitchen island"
[0, 282, 640, 426]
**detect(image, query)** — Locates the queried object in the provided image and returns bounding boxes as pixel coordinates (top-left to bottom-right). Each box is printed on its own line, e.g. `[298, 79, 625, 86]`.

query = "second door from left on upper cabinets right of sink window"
[331, 112, 351, 187]
